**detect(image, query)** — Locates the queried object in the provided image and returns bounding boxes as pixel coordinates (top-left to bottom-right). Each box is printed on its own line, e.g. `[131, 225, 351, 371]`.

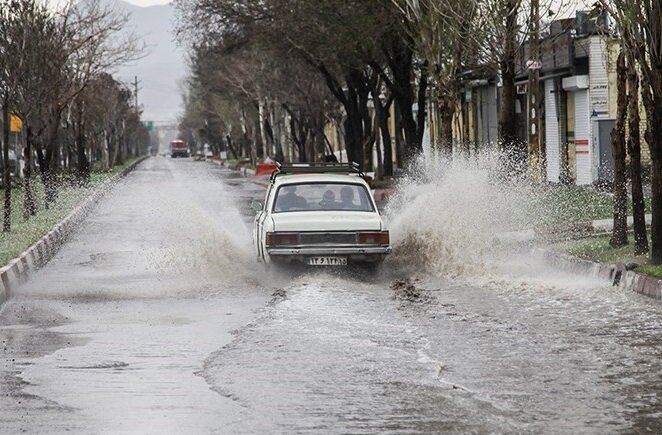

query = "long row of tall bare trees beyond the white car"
[175, 0, 550, 176]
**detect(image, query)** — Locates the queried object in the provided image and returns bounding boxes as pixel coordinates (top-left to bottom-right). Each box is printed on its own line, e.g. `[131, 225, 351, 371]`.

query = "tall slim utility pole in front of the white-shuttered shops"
[528, 0, 542, 181]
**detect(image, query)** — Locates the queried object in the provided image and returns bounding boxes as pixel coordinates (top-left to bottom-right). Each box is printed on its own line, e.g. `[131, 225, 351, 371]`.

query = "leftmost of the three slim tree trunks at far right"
[609, 51, 628, 247]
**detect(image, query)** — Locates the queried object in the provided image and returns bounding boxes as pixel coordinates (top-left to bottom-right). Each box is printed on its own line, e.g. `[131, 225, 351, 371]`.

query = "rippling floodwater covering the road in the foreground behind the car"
[204, 274, 662, 433]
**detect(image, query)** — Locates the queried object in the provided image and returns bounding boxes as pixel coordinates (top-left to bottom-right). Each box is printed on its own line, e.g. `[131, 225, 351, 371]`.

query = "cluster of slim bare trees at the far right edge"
[600, 0, 662, 264]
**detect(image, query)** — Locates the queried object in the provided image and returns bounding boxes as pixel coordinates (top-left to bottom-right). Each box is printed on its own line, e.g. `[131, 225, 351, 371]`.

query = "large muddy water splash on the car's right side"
[386, 152, 608, 287]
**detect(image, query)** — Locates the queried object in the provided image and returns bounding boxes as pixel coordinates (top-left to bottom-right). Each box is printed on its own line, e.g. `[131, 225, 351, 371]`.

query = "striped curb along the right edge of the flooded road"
[533, 248, 662, 300]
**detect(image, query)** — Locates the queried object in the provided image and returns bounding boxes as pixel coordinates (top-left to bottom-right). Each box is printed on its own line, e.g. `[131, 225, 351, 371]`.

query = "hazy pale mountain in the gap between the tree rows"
[108, 0, 187, 122]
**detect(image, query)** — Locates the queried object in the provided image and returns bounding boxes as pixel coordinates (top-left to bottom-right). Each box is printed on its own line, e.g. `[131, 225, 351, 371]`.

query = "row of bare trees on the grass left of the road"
[0, 0, 149, 232]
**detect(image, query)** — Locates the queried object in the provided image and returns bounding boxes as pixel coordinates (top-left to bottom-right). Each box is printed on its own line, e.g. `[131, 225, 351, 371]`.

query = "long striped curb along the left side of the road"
[0, 156, 148, 305]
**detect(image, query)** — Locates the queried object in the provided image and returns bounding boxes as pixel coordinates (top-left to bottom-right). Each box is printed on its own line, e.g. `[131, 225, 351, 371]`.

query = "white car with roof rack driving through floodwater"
[252, 163, 391, 266]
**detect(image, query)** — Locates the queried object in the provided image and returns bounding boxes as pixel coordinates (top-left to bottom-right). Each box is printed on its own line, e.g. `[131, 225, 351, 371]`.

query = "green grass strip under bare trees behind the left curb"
[0, 158, 143, 267]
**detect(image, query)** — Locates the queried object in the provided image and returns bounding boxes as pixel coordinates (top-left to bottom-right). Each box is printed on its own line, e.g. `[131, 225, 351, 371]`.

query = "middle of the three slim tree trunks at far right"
[627, 57, 648, 255]
